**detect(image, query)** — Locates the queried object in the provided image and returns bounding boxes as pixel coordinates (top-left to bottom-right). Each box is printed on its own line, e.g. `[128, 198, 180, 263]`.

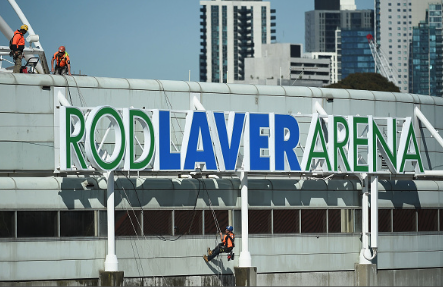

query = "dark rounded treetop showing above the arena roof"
[325, 73, 400, 92]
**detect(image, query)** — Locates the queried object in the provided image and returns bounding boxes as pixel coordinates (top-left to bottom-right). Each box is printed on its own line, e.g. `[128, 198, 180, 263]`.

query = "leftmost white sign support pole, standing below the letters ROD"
[105, 171, 118, 271]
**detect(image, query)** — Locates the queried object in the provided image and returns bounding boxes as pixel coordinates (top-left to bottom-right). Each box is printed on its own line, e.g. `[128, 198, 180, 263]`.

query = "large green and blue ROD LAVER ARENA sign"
[59, 106, 424, 173]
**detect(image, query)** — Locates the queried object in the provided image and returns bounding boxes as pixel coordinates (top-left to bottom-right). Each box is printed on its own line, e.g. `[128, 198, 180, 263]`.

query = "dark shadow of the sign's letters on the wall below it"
[59, 177, 420, 209]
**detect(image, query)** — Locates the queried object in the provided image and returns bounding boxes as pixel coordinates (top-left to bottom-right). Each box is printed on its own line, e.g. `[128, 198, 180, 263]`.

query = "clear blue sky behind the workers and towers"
[0, 0, 374, 81]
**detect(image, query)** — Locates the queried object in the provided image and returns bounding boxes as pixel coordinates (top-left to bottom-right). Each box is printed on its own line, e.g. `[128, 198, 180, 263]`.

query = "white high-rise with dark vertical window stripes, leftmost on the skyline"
[200, 0, 276, 83]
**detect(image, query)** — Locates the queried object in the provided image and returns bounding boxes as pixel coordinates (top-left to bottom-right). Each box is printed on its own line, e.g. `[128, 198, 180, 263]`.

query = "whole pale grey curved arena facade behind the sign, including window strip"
[0, 73, 443, 286]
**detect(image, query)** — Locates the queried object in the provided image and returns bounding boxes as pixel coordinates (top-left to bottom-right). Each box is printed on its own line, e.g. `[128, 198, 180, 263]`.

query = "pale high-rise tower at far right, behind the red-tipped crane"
[375, 0, 442, 93]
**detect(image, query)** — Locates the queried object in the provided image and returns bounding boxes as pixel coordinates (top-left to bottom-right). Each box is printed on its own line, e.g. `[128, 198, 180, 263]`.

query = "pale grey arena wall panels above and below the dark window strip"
[0, 74, 443, 285]
